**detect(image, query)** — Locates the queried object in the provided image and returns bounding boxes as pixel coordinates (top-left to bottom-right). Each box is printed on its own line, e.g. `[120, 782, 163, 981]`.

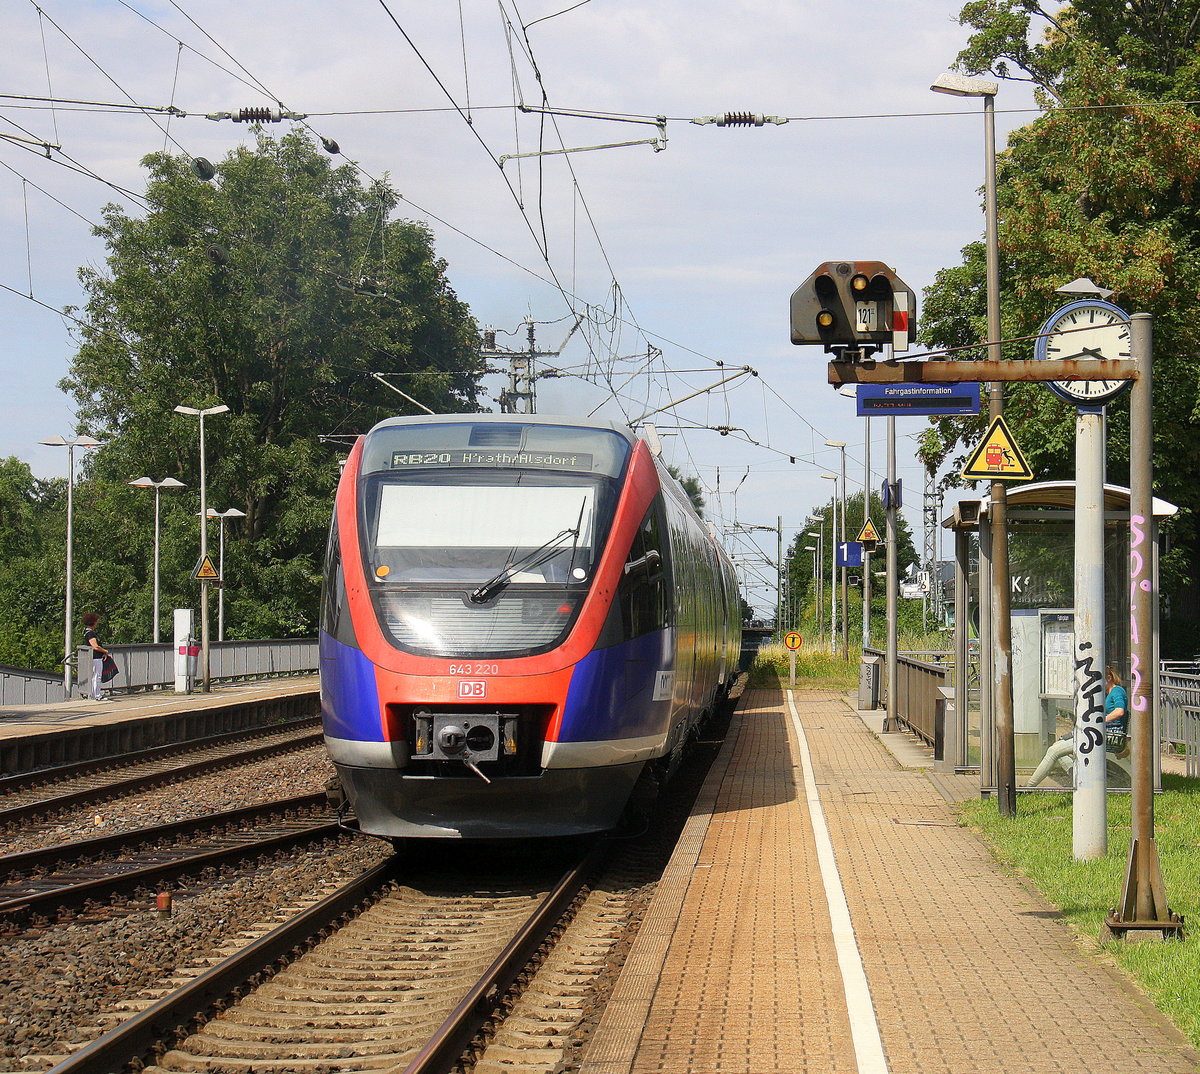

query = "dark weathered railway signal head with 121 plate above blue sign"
[791, 262, 917, 356]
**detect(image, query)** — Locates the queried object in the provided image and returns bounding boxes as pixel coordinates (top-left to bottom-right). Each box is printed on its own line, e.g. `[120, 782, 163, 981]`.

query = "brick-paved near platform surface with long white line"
[581, 690, 1200, 1074]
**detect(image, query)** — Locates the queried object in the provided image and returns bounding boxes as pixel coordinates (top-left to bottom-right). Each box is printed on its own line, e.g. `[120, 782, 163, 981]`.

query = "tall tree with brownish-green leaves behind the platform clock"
[920, 0, 1200, 652]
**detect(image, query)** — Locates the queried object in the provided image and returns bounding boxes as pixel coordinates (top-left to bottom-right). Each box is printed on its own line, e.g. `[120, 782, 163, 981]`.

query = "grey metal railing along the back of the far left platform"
[0, 638, 319, 706]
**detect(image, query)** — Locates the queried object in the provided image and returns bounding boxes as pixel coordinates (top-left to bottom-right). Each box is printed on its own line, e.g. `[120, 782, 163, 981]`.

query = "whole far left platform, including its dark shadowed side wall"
[0, 674, 319, 775]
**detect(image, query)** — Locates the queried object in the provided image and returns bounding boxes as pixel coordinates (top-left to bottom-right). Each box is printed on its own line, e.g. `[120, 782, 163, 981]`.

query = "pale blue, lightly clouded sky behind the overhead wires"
[0, 0, 1033, 602]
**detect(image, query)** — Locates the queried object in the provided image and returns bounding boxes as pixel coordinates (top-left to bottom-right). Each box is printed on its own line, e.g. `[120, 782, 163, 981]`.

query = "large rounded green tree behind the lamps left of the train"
[27, 131, 482, 641]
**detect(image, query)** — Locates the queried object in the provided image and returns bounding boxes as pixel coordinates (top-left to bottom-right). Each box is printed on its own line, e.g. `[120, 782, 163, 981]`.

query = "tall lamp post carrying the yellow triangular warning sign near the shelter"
[930, 72, 1016, 816]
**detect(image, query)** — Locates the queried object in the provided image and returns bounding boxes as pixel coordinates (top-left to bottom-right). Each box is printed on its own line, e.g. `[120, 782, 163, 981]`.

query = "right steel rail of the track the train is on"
[405, 839, 611, 1074]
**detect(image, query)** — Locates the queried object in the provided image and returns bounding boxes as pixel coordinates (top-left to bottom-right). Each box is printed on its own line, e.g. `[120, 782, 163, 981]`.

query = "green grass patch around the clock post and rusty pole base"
[959, 775, 1200, 1046]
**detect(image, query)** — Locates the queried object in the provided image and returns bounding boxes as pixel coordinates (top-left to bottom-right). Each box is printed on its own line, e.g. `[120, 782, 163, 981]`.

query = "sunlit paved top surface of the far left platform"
[0, 674, 320, 738]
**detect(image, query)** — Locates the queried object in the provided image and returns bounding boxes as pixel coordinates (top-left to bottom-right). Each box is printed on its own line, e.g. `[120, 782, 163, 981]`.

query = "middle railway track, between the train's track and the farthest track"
[0, 794, 340, 918]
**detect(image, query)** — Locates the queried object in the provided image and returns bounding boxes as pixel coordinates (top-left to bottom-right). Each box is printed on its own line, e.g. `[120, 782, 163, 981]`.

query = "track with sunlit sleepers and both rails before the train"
[44, 846, 606, 1074]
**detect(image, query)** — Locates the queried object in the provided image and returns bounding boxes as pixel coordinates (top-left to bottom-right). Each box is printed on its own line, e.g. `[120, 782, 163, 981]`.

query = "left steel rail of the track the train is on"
[47, 858, 396, 1074]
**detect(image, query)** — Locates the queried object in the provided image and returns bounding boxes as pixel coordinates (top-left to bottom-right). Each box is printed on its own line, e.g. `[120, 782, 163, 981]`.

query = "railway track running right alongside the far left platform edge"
[0, 719, 322, 828]
